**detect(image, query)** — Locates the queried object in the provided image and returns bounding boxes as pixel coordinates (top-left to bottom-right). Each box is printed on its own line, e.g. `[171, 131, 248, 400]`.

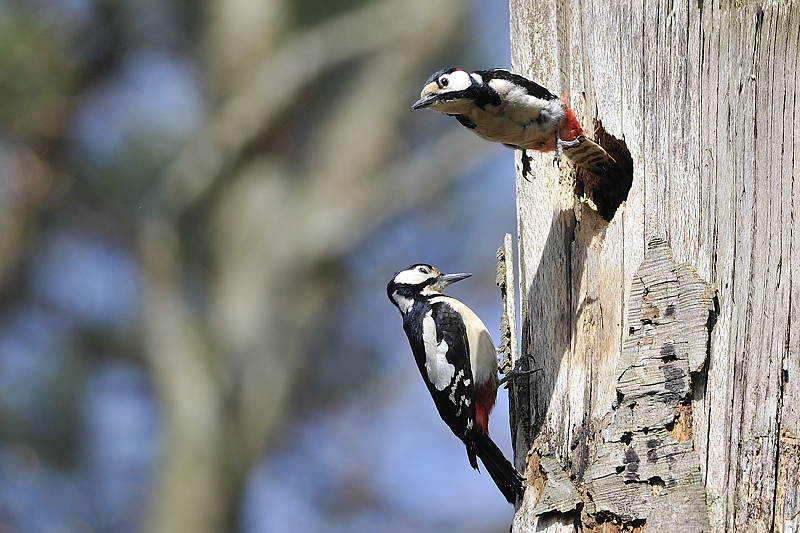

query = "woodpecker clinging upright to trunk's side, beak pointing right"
[387, 264, 523, 504]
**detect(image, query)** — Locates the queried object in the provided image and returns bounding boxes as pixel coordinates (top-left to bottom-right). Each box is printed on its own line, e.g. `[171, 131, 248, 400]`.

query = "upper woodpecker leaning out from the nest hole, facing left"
[413, 67, 616, 173]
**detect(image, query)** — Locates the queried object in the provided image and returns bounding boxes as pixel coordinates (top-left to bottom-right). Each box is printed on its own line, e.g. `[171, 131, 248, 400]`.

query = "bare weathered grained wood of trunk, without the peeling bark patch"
[511, 0, 800, 532]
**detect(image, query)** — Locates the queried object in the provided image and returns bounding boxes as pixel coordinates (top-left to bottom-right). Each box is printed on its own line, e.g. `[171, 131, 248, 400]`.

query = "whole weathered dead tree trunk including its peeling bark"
[511, 0, 800, 533]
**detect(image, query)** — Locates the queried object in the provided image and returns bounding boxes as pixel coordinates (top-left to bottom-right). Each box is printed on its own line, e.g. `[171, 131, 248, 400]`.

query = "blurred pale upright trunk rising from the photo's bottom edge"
[139, 216, 227, 531]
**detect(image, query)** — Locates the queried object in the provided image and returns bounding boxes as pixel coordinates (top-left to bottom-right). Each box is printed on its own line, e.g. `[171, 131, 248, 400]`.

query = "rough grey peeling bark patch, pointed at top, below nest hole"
[584, 239, 715, 533]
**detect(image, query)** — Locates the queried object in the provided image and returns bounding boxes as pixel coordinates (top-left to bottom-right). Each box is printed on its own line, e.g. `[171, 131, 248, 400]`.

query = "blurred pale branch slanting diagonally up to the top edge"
[160, 0, 463, 216]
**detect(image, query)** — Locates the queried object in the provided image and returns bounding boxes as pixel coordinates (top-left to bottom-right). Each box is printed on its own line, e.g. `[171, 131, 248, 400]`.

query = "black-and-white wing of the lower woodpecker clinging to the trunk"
[403, 302, 478, 469]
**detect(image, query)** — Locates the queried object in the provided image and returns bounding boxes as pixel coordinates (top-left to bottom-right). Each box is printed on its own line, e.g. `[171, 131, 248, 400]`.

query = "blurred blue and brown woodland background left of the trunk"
[0, 0, 516, 533]
